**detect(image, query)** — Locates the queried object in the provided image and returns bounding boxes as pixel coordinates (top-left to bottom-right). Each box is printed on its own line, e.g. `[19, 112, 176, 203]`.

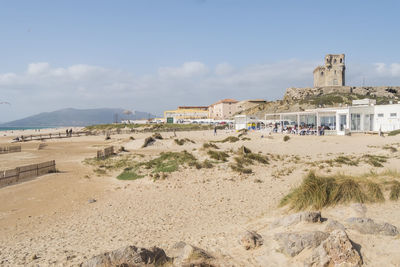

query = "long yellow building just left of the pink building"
[164, 106, 208, 123]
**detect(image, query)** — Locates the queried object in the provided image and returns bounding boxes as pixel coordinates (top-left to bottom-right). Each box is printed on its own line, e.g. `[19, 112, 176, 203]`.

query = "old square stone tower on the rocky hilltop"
[314, 54, 346, 87]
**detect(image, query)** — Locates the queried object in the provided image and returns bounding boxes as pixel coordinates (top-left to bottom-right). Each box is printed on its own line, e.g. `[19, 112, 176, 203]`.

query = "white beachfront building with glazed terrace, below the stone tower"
[265, 99, 400, 135]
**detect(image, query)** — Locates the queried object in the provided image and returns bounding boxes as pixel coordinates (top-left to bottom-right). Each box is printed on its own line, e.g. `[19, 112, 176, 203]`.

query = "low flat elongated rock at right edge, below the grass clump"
[345, 217, 399, 236]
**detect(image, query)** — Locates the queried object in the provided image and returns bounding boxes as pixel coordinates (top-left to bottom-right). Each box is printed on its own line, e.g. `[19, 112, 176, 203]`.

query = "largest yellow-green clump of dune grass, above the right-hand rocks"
[280, 172, 400, 210]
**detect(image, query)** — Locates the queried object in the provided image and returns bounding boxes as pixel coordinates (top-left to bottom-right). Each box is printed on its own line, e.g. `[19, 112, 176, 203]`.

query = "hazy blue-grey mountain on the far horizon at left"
[0, 108, 155, 127]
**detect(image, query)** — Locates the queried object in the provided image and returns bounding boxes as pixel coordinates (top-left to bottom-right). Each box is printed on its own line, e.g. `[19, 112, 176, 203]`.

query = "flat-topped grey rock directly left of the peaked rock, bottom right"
[274, 231, 329, 257]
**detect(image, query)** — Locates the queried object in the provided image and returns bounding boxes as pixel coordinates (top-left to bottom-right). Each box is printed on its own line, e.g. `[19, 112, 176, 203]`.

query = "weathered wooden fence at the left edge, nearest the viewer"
[0, 160, 56, 187]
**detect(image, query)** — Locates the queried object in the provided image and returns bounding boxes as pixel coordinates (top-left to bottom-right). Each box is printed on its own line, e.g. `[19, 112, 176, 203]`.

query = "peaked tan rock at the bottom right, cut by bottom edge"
[304, 230, 362, 267]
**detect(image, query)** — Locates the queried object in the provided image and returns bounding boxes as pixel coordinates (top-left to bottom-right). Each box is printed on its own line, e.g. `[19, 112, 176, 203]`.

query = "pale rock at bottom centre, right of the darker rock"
[168, 242, 214, 267]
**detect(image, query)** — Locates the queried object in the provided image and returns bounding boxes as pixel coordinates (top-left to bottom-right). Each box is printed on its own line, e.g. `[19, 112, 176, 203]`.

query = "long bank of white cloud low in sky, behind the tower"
[0, 59, 400, 121]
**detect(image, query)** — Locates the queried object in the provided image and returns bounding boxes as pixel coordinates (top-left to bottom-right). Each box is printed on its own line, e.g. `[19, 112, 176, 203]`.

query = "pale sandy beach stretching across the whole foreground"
[0, 129, 400, 266]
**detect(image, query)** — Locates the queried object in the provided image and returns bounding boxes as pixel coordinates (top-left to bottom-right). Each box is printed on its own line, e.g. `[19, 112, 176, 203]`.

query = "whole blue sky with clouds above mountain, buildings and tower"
[0, 0, 400, 122]
